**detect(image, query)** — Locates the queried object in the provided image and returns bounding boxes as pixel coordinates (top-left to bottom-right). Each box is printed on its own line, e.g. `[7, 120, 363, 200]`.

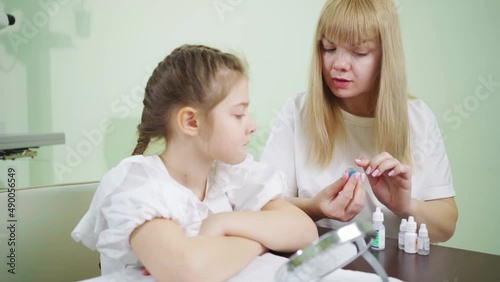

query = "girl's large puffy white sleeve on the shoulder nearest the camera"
[71, 156, 193, 264]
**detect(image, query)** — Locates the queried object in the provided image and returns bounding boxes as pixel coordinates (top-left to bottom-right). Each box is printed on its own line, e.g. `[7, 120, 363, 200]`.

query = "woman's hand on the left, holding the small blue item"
[313, 171, 365, 221]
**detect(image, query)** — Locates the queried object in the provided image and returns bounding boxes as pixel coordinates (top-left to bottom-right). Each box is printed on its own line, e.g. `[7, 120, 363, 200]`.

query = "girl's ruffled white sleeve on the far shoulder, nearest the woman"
[215, 155, 286, 211]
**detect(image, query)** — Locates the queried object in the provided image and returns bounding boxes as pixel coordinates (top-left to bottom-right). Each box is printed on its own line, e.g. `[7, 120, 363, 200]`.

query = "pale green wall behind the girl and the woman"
[0, 0, 500, 255]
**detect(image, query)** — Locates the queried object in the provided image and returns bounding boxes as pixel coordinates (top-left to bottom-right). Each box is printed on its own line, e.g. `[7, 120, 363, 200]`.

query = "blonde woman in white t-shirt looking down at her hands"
[261, 0, 458, 241]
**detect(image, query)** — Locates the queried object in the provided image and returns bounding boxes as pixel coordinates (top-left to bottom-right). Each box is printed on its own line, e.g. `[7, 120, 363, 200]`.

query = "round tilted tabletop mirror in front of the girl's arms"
[275, 222, 389, 282]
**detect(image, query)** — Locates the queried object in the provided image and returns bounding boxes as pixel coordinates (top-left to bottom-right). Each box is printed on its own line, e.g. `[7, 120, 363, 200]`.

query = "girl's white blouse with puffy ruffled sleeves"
[71, 155, 286, 275]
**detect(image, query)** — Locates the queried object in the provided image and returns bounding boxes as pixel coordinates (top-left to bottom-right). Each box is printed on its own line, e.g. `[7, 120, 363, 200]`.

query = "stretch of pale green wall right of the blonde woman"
[400, 0, 500, 255]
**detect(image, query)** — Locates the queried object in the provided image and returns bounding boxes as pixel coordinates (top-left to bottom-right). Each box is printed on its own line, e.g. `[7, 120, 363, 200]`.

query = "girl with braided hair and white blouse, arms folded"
[72, 45, 318, 281]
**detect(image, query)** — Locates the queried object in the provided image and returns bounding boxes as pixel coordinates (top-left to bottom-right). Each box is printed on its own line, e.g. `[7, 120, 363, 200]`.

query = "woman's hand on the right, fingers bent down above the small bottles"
[354, 152, 413, 217]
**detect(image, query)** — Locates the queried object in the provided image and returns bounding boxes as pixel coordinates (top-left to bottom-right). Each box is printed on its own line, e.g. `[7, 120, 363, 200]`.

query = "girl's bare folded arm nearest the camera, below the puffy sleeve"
[130, 219, 265, 281]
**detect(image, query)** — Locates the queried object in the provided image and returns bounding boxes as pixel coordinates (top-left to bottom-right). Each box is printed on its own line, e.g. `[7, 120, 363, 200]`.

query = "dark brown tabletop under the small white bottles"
[318, 227, 500, 282]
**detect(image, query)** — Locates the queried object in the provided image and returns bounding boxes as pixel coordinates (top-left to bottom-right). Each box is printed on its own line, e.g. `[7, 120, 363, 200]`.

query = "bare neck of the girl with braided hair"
[160, 142, 213, 200]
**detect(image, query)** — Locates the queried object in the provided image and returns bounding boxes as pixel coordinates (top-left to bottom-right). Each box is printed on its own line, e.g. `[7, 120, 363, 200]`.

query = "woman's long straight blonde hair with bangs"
[302, 0, 411, 167]
